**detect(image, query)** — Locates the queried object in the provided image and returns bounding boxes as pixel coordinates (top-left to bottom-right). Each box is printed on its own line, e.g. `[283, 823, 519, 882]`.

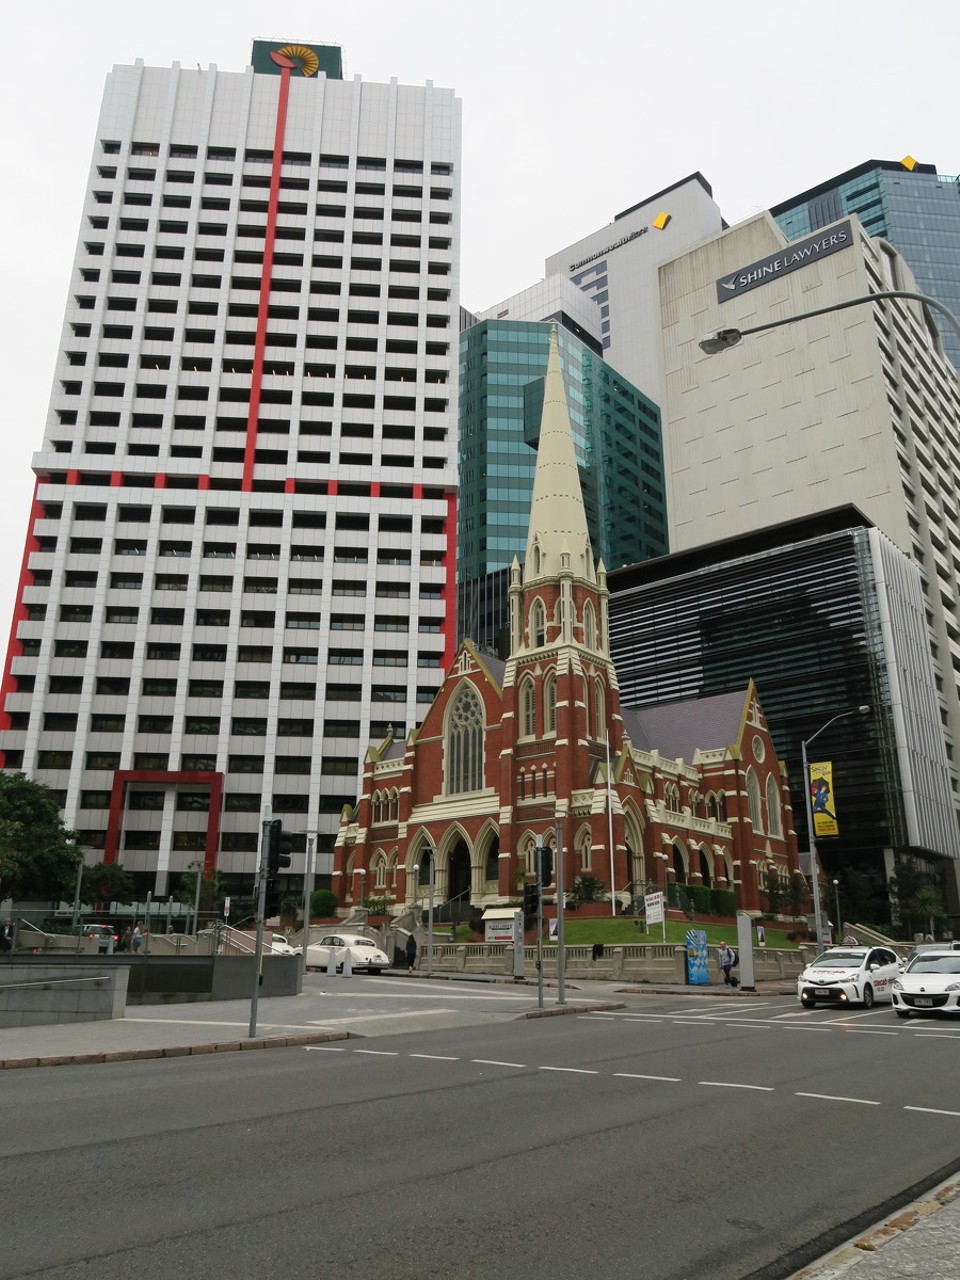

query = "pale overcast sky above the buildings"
[0, 0, 960, 646]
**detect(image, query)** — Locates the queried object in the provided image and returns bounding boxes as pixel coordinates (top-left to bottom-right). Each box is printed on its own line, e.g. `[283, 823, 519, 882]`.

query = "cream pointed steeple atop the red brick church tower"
[524, 326, 596, 584]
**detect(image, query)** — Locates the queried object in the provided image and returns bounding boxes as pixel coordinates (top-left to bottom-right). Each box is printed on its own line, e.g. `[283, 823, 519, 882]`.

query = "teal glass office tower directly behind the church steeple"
[457, 320, 668, 648]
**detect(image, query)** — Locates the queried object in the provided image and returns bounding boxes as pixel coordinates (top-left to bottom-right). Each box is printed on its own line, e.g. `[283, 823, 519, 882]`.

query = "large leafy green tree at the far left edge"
[0, 773, 83, 902]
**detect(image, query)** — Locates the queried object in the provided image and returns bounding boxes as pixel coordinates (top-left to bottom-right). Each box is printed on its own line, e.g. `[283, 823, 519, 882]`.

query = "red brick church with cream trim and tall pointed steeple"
[333, 325, 797, 918]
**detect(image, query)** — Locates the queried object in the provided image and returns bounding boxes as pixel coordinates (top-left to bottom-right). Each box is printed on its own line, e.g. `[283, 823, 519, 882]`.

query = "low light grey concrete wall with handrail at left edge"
[0, 964, 127, 1028]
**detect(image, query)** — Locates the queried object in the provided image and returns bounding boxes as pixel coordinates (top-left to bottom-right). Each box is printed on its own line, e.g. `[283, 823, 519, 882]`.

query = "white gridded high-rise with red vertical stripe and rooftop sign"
[3, 42, 461, 893]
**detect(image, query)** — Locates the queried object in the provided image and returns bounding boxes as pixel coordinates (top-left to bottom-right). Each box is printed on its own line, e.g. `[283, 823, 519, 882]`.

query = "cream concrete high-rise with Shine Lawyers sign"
[659, 214, 960, 839]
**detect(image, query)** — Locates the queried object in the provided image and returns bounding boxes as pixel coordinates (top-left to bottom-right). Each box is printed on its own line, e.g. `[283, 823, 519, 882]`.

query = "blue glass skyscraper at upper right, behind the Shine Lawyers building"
[771, 156, 960, 369]
